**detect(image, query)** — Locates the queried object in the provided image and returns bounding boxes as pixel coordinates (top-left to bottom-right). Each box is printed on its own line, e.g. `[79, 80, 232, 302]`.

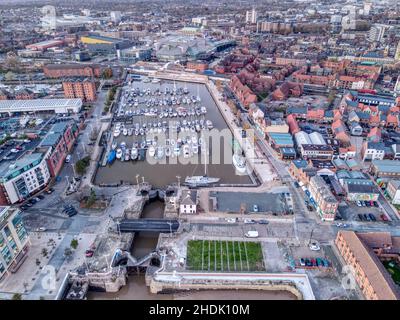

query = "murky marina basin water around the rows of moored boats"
[95, 81, 252, 187]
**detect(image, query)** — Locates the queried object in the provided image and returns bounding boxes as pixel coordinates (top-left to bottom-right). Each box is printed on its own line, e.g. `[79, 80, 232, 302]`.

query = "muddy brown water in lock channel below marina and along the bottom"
[87, 201, 296, 300]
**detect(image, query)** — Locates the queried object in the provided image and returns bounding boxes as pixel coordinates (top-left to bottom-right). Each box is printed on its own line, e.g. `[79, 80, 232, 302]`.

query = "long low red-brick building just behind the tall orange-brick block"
[43, 63, 101, 78]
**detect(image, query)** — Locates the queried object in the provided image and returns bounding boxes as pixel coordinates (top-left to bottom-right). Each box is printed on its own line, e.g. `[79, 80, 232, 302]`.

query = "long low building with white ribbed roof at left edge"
[0, 99, 82, 115]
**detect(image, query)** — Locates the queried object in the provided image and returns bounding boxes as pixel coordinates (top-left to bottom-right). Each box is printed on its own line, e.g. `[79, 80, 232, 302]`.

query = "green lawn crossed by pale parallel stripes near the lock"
[187, 240, 265, 272]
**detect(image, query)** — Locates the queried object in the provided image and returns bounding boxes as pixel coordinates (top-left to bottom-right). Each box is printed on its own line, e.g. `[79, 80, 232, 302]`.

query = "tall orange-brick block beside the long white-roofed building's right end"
[63, 78, 97, 102]
